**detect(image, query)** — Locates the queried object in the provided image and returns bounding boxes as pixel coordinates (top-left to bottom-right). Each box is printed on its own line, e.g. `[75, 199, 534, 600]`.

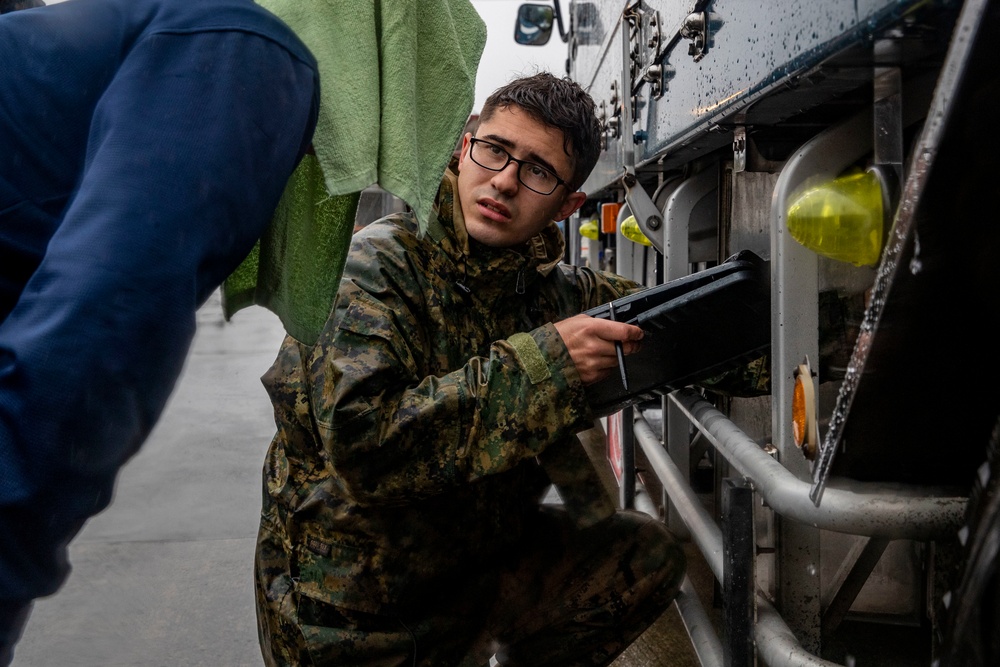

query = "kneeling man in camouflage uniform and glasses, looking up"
[256, 74, 685, 667]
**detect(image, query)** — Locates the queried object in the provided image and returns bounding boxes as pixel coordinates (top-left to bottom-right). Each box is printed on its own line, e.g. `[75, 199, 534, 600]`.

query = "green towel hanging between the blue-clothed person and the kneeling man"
[223, 0, 486, 344]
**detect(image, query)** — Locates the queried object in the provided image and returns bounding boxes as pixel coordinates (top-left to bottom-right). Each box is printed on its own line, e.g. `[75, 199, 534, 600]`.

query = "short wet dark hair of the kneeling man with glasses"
[479, 72, 601, 190]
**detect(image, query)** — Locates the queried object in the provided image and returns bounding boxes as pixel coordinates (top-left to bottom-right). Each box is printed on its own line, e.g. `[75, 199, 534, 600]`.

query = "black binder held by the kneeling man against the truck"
[586, 250, 771, 417]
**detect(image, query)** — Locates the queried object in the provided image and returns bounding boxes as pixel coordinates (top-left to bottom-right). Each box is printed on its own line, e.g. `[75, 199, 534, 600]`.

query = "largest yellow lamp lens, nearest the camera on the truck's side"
[787, 172, 885, 266]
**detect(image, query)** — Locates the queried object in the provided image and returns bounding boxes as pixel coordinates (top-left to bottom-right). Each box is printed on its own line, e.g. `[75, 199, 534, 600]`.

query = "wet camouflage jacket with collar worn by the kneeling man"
[263, 166, 636, 612]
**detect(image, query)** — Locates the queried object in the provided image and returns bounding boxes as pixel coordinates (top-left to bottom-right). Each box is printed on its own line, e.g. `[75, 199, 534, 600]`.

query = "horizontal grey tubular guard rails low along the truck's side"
[633, 390, 966, 667]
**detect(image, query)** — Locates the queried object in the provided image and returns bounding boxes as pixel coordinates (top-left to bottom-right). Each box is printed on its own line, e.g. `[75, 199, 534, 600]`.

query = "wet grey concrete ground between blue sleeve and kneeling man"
[13, 295, 711, 667]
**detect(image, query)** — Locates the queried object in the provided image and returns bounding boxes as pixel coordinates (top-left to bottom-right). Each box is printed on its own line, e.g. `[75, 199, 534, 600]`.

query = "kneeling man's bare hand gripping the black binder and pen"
[555, 315, 643, 384]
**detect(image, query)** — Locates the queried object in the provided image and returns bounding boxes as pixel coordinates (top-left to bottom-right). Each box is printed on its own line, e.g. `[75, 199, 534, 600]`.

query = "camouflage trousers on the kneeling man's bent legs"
[256, 507, 686, 667]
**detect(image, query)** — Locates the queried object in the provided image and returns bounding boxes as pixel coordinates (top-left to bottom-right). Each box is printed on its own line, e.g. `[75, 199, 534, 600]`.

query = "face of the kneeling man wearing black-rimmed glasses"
[458, 107, 586, 248]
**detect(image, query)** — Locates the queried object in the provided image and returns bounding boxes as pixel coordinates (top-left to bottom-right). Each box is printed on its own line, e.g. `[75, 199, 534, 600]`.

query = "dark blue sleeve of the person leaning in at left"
[0, 18, 317, 656]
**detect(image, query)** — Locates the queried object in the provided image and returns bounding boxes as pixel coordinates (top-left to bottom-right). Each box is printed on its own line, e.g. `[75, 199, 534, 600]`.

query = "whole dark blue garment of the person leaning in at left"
[0, 0, 319, 664]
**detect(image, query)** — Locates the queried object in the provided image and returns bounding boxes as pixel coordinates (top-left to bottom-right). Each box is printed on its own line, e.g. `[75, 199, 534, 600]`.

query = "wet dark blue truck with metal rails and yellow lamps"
[514, 0, 1000, 667]
